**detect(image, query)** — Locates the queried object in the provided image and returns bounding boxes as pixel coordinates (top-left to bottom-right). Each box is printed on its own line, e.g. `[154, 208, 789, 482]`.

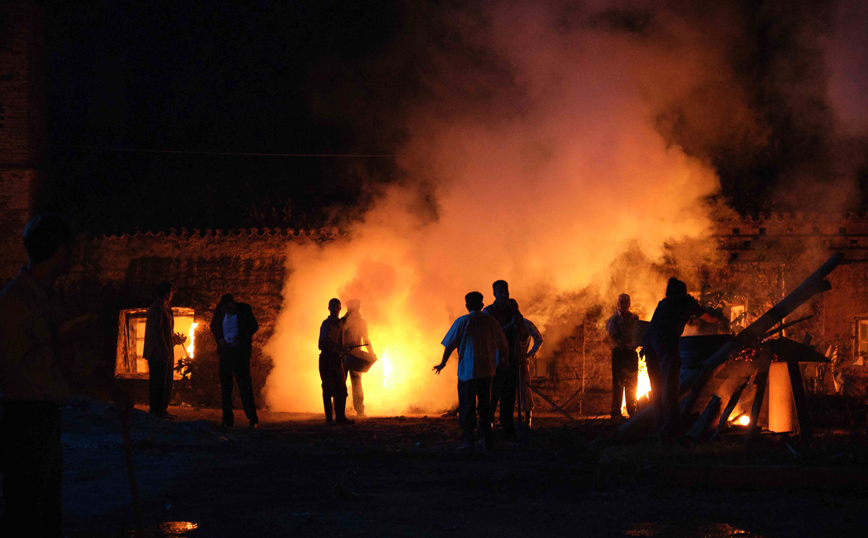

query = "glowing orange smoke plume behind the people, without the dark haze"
[267, 2, 728, 413]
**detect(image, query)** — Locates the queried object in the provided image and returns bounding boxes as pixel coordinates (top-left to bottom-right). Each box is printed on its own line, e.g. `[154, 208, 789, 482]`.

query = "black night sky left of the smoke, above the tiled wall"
[40, 0, 401, 231]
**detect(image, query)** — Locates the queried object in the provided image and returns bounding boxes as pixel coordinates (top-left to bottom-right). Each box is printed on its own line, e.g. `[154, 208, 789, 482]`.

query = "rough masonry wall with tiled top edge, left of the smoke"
[64, 230, 332, 405]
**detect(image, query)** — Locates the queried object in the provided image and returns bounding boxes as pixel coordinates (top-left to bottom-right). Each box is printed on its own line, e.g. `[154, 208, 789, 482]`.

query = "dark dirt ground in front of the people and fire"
[6, 401, 868, 538]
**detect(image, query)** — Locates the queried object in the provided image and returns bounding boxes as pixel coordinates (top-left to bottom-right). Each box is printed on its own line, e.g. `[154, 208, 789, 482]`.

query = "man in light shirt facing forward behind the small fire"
[606, 293, 639, 419]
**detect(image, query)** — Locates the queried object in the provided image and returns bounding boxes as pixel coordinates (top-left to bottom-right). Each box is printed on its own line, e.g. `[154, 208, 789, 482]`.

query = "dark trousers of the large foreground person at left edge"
[0, 401, 63, 537]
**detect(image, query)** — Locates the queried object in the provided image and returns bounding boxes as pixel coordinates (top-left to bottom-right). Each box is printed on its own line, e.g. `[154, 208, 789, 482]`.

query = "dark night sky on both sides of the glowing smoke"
[39, 0, 868, 232]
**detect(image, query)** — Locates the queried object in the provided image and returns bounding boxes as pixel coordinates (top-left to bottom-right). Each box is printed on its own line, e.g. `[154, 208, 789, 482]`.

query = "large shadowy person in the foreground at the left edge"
[0, 214, 132, 538]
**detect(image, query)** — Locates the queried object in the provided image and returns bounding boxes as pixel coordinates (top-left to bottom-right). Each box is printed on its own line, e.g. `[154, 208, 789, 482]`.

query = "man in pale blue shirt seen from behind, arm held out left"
[434, 291, 508, 450]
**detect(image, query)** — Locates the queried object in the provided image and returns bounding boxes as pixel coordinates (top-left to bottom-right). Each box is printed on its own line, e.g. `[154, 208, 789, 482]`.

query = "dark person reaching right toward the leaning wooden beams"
[642, 278, 717, 441]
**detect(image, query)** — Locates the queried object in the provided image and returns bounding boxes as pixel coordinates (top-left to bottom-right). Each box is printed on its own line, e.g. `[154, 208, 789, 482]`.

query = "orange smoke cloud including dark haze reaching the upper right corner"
[268, 0, 866, 413]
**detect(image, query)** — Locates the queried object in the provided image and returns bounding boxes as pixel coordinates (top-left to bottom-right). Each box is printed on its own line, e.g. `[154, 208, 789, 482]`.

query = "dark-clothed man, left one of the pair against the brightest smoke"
[319, 299, 353, 424]
